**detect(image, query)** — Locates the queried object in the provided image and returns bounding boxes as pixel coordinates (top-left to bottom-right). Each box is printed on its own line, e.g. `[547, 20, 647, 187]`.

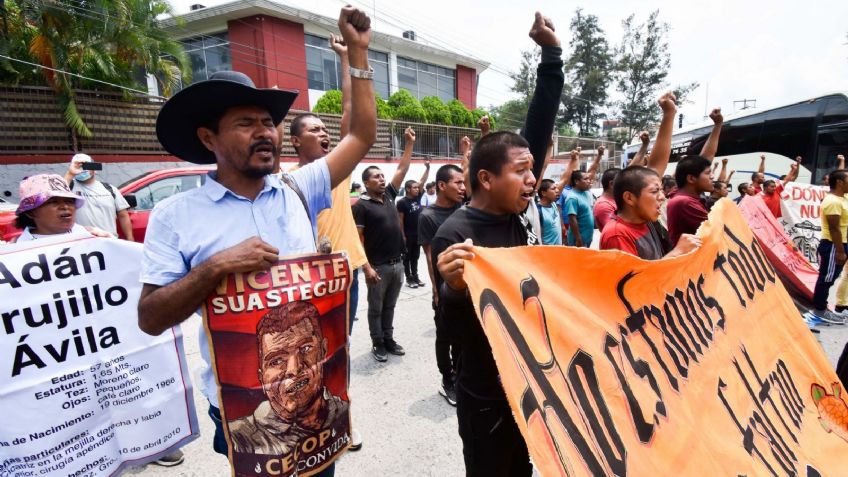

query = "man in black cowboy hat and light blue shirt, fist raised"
[138, 6, 377, 475]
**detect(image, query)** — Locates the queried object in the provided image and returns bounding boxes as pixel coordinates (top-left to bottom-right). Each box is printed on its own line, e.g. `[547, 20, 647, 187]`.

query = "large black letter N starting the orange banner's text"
[479, 278, 626, 477]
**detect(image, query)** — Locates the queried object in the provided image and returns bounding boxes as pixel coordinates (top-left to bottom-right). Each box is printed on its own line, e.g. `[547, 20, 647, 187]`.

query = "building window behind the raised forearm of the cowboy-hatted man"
[303, 33, 389, 99]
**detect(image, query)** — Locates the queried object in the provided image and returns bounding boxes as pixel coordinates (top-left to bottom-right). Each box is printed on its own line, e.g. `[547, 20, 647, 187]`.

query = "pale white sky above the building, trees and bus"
[170, 0, 848, 131]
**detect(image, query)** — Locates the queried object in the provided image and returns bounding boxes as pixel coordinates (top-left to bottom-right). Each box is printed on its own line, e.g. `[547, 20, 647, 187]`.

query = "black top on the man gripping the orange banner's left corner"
[431, 206, 538, 400]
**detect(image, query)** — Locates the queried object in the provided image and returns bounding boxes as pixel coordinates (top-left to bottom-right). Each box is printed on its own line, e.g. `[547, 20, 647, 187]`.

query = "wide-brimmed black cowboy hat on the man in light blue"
[156, 71, 298, 164]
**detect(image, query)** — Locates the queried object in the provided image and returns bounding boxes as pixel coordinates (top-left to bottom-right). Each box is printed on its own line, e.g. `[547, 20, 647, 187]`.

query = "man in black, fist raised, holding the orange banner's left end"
[431, 12, 564, 477]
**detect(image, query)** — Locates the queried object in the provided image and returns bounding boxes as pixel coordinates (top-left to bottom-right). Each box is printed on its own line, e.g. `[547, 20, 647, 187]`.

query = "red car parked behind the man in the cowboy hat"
[0, 166, 215, 242]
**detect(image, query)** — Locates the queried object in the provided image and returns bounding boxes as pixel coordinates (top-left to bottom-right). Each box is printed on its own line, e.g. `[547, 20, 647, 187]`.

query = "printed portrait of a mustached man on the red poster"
[227, 301, 348, 456]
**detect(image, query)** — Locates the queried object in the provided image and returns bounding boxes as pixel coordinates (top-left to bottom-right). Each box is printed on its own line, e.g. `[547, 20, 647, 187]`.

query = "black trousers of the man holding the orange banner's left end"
[456, 386, 533, 477]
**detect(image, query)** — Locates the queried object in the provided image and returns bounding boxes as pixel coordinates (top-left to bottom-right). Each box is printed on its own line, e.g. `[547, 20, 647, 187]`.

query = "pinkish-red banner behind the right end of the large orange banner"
[739, 196, 819, 304]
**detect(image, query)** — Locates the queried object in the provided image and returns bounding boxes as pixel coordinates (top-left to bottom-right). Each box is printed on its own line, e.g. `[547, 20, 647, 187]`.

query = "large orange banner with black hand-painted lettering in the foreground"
[465, 201, 848, 477]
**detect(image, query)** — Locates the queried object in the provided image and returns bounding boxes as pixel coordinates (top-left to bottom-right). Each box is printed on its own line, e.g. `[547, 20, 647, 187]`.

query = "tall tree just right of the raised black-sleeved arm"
[560, 8, 614, 136]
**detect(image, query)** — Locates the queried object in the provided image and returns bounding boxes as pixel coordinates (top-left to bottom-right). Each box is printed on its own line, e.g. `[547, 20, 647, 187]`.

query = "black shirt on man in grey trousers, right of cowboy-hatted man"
[353, 184, 404, 265]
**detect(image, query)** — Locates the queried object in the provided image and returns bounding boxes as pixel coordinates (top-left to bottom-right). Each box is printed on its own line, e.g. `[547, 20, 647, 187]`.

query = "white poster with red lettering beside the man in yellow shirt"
[780, 182, 830, 268]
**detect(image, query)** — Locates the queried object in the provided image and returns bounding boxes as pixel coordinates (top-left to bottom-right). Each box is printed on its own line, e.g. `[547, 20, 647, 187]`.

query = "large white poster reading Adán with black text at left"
[0, 235, 199, 476]
